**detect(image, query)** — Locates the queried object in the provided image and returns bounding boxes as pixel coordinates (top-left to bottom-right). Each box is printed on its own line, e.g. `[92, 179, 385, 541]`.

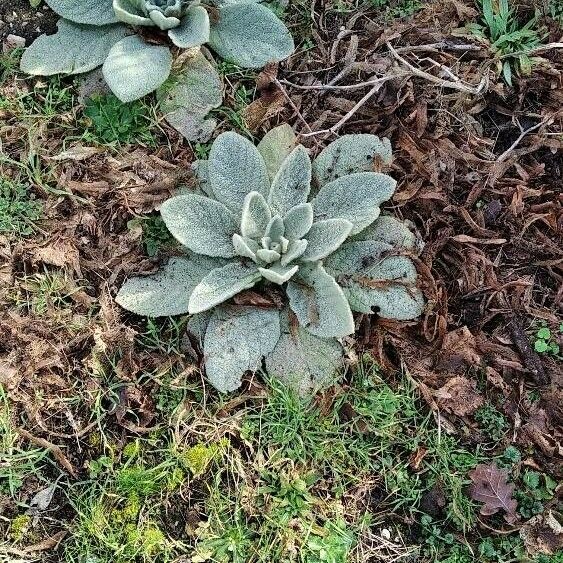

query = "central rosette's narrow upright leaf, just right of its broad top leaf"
[268, 145, 311, 216]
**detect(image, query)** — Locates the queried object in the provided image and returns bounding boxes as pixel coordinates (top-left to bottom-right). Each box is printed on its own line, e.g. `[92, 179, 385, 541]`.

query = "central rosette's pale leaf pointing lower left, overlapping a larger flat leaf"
[189, 262, 261, 314]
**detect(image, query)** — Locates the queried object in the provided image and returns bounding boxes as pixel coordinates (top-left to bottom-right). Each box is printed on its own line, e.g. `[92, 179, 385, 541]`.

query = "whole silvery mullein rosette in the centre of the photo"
[117, 125, 424, 392]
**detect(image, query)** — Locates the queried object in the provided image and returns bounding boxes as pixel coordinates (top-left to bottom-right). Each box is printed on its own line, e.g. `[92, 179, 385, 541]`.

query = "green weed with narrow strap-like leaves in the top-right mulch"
[468, 0, 543, 86]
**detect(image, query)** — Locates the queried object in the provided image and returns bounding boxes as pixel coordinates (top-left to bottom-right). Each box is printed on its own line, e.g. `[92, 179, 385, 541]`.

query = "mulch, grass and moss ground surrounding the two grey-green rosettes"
[0, 0, 563, 563]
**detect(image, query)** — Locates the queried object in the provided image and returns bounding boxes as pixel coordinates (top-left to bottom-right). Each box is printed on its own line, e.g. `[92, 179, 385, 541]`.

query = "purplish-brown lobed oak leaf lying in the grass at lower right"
[468, 463, 518, 524]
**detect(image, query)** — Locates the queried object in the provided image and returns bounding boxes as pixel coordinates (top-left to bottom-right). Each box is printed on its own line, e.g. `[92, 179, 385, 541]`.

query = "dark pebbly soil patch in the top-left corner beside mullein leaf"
[0, 0, 59, 45]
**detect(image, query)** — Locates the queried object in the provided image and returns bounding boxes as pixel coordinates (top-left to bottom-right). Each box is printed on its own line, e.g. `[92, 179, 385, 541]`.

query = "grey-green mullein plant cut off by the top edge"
[21, 0, 294, 139]
